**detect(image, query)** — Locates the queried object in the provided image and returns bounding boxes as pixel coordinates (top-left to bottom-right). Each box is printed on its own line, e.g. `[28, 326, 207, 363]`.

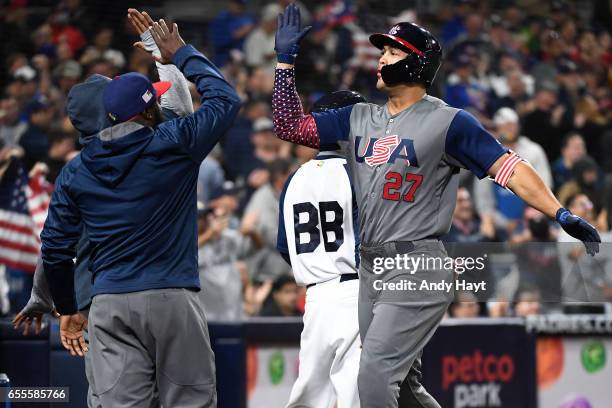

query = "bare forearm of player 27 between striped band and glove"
[508, 162, 561, 219]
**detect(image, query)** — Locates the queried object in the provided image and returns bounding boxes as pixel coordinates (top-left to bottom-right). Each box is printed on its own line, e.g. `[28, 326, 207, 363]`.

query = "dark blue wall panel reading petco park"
[420, 319, 537, 408]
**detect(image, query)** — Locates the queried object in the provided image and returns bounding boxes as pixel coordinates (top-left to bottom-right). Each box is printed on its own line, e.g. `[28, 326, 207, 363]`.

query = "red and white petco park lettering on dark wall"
[442, 350, 514, 408]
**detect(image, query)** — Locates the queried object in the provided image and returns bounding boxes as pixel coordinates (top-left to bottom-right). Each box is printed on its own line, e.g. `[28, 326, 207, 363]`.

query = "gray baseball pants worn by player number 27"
[358, 240, 454, 408]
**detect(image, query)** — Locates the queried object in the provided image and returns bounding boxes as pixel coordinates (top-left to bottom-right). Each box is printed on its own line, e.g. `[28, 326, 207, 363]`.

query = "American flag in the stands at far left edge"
[0, 160, 52, 272]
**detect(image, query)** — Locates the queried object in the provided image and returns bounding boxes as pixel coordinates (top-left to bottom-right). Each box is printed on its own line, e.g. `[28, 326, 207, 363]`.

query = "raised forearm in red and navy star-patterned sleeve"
[272, 66, 319, 149]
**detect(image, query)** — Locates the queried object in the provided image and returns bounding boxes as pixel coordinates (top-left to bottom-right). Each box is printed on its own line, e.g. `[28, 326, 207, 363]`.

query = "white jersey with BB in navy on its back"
[277, 152, 359, 285]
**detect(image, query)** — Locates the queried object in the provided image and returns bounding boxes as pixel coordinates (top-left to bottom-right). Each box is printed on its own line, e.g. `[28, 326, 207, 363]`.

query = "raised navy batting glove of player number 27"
[274, 3, 312, 64]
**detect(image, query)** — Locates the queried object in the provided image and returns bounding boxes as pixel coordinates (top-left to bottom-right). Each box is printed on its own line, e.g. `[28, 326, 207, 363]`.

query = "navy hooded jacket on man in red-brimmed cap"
[41, 46, 240, 314]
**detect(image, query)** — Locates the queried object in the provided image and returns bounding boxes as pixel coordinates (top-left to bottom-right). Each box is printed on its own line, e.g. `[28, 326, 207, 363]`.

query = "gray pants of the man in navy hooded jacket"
[88, 289, 217, 408]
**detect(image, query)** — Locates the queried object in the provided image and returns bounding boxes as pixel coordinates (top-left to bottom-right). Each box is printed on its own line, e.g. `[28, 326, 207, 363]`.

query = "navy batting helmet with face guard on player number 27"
[370, 23, 442, 87]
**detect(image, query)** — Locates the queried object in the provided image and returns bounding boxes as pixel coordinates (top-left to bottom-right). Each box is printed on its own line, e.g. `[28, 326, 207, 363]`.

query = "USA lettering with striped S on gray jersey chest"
[355, 135, 419, 167]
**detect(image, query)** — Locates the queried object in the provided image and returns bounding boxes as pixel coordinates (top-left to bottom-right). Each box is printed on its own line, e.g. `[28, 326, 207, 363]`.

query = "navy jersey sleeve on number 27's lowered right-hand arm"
[445, 110, 509, 178]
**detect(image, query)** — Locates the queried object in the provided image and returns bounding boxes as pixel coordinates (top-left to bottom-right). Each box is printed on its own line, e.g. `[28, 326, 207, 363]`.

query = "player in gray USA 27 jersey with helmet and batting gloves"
[273, 4, 601, 408]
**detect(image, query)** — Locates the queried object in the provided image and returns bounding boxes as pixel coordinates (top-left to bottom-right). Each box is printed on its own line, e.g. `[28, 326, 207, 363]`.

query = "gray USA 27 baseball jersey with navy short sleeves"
[312, 95, 507, 244]
